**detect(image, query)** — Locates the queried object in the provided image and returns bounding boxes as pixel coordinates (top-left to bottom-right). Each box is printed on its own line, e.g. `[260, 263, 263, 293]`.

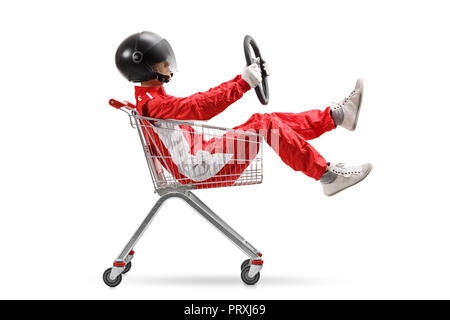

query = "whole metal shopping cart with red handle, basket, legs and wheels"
[103, 99, 263, 287]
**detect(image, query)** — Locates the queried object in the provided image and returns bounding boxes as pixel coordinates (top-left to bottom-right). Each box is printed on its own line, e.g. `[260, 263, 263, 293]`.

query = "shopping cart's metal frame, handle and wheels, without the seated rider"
[103, 99, 263, 287]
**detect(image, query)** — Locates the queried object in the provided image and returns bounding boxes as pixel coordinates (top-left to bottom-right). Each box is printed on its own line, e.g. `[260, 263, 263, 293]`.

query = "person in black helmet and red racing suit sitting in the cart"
[116, 31, 372, 196]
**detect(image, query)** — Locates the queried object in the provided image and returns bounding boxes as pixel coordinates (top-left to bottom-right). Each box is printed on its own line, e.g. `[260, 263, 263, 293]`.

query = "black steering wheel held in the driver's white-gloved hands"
[244, 35, 269, 105]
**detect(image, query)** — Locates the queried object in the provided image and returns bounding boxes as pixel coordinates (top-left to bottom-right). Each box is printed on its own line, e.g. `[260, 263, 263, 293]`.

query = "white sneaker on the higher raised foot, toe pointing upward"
[331, 79, 364, 131]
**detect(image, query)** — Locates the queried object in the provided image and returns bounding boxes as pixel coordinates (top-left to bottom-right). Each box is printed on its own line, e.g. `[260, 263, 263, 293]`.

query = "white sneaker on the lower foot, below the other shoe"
[321, 163, 372, 196]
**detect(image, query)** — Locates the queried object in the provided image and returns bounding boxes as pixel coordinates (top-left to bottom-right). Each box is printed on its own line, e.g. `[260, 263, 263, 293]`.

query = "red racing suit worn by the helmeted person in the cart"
[135, 75, 336, 184]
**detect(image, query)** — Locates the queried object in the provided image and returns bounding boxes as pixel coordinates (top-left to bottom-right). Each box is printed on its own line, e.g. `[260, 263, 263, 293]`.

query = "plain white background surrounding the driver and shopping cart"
[0, 0, 450, 299]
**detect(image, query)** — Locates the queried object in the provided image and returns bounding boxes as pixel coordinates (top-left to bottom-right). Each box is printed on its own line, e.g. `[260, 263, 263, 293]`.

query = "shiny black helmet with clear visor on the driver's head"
[116, 31, 177, 82]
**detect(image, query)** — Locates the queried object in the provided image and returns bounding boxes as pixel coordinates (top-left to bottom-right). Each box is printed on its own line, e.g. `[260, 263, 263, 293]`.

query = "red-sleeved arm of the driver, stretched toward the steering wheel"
[143, 75, 250, 120]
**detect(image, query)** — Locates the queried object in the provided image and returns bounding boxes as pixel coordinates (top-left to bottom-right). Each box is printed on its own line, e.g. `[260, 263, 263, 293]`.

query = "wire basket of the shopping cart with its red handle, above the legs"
[110, 100, 263, 194]
